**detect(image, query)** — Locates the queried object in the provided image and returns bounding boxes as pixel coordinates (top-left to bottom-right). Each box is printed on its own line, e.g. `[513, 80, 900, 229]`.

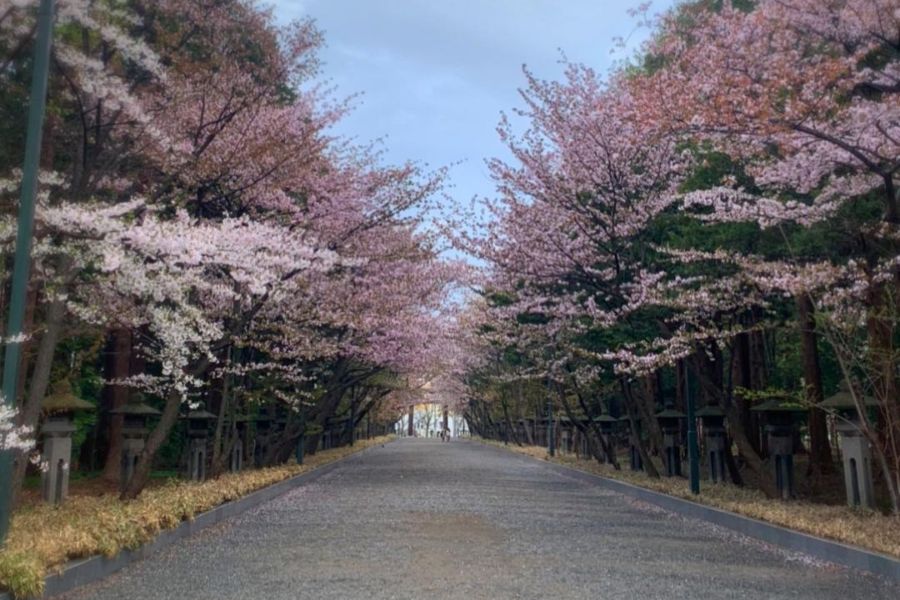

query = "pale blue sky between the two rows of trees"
[268, 0, 672, 210]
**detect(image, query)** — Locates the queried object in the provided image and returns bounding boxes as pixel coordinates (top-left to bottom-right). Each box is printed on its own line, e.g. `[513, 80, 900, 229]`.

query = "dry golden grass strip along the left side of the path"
[0, 436, 392, 598]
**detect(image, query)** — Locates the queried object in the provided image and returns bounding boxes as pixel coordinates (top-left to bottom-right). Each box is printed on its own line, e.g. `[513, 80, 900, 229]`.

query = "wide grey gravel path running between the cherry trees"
[60, 440, 900, 600]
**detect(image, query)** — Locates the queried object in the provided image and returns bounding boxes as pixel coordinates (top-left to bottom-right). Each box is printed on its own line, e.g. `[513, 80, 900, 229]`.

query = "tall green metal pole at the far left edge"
[0, 0, 53, 545]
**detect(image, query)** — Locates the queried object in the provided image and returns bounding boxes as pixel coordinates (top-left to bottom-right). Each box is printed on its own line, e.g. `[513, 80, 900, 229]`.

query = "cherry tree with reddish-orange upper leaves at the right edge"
[635, 0, 900, 509]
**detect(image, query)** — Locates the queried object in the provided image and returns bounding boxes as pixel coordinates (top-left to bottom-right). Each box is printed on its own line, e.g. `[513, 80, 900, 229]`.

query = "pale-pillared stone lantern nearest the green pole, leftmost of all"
[41, 381, 94, 504]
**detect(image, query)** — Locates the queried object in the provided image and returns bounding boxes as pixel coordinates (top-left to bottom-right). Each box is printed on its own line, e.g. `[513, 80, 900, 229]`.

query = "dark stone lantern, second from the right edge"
[750, 397, 807, 500]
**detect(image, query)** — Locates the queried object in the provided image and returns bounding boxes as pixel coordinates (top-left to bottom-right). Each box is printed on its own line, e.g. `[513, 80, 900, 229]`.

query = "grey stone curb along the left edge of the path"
[0, 440, 395, 600]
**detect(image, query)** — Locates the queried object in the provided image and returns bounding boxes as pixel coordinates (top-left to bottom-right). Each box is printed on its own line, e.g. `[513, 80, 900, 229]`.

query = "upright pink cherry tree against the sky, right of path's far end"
[454, 65, 686, 474]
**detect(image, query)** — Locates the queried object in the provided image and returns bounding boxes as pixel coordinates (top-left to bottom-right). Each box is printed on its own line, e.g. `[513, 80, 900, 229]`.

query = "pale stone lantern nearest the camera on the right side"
[819, 380, 878, 508]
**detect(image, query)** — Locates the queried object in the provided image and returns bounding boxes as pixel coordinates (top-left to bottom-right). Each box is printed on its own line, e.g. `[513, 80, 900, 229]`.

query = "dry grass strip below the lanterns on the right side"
[480, 440, 900, 558]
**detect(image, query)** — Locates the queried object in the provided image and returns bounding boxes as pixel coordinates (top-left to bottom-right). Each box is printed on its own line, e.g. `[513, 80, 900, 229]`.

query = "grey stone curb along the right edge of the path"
[472, 443, 900, 583]
